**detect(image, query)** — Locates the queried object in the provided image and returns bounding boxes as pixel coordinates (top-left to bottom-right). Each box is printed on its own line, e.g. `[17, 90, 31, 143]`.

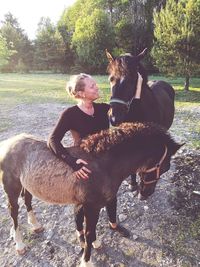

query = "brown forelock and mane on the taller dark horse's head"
[107, 53, 148, 84]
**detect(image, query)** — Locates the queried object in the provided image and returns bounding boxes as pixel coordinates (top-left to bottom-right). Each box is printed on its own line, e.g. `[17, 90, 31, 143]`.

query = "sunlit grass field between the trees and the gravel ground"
[0, 73, 200, 107]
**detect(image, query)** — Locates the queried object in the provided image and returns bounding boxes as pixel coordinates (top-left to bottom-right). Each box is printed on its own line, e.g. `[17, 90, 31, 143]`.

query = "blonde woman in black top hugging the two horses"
[48, 73, 129, 246]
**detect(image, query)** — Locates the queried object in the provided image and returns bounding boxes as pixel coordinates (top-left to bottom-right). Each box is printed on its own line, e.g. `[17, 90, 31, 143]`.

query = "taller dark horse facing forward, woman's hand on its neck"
[106, 49, 175, 191]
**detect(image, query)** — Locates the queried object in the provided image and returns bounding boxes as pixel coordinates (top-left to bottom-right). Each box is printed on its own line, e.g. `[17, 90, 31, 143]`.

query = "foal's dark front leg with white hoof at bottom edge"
[80, 205, 100, 267]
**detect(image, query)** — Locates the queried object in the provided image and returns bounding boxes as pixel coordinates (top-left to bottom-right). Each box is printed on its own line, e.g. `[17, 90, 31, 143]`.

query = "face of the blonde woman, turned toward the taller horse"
[82, 77, 99, 101]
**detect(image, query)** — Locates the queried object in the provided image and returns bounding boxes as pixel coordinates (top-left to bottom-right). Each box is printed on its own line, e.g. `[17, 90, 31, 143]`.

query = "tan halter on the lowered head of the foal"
[139, 146, 167, 185]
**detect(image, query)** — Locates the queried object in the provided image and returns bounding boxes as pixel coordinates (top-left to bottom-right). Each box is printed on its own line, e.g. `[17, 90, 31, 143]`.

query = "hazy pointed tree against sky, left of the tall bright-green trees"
[34, 18, 65, 72]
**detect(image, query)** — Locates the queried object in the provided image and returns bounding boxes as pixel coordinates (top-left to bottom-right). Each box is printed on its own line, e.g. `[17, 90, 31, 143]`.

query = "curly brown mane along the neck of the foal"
[80, 122, 171, 154]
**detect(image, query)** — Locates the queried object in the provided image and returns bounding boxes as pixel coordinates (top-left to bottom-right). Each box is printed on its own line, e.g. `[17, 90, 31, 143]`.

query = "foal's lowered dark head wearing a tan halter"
[138, 141, 183, 200]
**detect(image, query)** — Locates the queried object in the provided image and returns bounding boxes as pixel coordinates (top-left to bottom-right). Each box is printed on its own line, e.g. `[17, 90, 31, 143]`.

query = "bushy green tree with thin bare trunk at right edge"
[152, 0, 200, 90]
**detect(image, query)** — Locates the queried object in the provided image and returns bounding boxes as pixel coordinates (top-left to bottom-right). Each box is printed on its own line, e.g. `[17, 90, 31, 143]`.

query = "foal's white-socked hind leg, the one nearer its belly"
[23, 189, 44, 233]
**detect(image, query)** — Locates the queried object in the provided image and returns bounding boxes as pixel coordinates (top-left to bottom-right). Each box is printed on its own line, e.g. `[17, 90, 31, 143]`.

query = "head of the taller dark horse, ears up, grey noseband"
[106, 49, 147, 125]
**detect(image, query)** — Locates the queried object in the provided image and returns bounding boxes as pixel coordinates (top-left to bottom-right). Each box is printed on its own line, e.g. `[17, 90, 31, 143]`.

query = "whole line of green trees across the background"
[0, 0, 200, 89]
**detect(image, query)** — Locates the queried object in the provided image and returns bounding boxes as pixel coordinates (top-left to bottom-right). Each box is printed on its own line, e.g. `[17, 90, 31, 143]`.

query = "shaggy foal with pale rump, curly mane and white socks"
[0, 123, 181, 266]
